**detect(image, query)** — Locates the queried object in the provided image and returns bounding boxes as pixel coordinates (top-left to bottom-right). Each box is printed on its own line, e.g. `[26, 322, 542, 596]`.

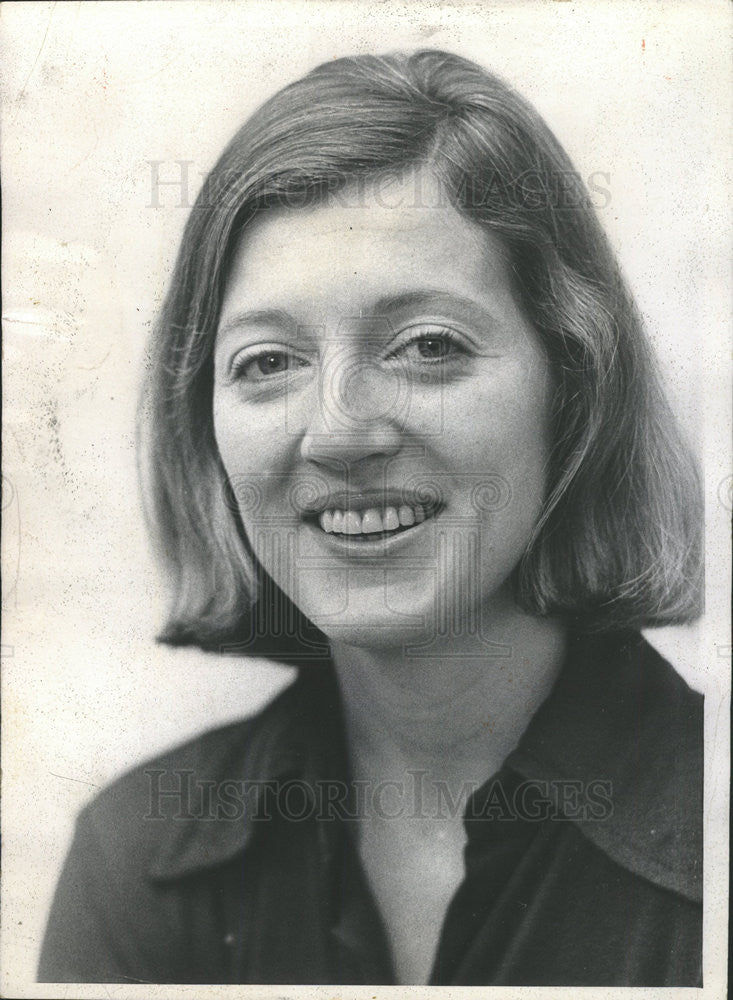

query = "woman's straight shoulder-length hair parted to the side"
[141, 50, 702, 659]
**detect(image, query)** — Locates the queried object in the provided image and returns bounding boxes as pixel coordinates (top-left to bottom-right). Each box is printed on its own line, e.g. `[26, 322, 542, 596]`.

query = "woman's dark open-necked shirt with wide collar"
[39, 634, 702, 986]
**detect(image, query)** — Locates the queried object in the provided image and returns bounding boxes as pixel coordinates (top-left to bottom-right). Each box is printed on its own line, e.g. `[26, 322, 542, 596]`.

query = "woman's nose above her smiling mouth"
[301, 351, 408, 470]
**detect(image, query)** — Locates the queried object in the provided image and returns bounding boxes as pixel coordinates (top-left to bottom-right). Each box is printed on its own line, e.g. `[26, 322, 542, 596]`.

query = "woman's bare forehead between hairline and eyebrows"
[222, 173, 509, 320]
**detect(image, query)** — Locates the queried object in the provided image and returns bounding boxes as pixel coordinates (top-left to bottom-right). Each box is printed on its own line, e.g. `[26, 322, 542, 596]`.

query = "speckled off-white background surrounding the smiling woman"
[0, 0, 731, 996]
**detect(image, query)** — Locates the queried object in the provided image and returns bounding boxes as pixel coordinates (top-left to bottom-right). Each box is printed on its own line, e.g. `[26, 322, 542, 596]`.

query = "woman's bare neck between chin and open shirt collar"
[332, 606, 565, 804]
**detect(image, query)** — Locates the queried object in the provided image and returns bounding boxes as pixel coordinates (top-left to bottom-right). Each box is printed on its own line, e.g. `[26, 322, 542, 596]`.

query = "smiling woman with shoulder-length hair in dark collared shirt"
[40, 51, 702, 986]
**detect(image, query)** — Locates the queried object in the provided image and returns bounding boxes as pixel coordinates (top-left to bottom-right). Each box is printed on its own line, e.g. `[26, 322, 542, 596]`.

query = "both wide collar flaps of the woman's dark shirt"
[149, 633, 702, 900]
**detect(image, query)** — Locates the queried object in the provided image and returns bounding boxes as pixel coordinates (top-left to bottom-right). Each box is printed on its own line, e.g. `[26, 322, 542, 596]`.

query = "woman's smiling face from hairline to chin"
[214, 175, 552, 653]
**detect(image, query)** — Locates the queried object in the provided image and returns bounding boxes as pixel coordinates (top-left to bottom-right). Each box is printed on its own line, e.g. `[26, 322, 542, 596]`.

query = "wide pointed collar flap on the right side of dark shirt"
[510, 633, 703, 902]
